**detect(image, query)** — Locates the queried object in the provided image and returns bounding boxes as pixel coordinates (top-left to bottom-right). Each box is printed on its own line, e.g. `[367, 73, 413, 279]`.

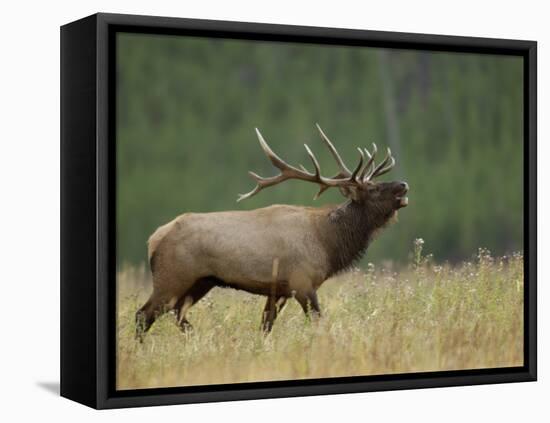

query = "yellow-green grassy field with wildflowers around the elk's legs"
[117, 242, 523, 389]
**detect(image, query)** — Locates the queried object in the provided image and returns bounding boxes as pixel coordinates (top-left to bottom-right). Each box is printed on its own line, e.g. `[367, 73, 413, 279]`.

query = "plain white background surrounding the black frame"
[0, 0, 550, 423]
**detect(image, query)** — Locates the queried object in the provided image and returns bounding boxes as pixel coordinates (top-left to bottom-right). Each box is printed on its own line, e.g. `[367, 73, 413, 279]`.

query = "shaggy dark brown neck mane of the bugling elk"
[323, 200, 395, 277]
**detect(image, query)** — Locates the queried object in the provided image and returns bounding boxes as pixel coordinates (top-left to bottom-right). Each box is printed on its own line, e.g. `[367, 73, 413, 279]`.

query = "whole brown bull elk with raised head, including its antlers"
[136, 125, 408, 340]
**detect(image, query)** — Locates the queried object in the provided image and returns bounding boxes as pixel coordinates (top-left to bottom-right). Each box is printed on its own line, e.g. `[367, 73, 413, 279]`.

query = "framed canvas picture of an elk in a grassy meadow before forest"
[115, 32, 525, 390]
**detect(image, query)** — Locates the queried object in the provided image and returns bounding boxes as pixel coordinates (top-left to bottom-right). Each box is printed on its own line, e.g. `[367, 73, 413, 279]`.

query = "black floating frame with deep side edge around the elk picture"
[61, 13, 537, 409]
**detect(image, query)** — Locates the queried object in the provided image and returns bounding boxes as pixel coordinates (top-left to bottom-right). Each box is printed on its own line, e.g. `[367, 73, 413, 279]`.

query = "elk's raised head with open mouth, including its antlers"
[237, 125, 409, 214]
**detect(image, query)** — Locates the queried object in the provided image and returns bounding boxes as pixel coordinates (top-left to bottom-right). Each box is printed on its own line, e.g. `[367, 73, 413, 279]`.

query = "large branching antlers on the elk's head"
[237, 124, 395, 202]
